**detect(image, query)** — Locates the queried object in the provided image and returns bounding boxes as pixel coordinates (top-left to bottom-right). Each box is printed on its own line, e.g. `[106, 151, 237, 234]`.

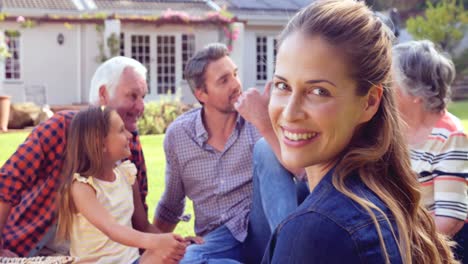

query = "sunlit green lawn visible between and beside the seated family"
[0, 101, 468, 236]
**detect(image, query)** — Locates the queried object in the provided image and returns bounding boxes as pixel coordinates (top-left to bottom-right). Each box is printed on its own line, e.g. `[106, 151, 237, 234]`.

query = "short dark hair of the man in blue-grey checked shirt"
[184, 43, 229, 94]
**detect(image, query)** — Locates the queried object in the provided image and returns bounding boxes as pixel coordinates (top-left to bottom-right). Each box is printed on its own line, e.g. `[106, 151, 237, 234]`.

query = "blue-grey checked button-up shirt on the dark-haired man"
[156, 108, 261, 241]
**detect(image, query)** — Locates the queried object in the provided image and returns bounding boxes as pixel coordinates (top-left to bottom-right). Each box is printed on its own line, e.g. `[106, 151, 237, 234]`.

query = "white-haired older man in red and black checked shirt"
[0, 57, 148, 256]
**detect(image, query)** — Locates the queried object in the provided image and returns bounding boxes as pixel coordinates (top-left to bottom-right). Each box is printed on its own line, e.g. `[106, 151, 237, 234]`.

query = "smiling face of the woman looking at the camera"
[269, 32, 374, 177]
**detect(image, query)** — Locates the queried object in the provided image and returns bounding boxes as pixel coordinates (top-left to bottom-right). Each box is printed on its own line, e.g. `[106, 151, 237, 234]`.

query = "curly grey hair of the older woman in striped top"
[393, 40, 455, 112]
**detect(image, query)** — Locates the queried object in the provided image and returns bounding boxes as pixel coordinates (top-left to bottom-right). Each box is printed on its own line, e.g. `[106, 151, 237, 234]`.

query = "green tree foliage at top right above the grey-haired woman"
[406, 0, 468, 52]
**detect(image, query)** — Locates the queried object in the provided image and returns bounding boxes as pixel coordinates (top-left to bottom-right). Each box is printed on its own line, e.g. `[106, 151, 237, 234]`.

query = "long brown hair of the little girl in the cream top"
[56, 107, 113, 240]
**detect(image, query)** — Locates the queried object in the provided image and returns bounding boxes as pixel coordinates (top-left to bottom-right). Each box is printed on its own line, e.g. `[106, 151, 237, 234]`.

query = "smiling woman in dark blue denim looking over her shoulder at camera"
[263, 0, 455, 263]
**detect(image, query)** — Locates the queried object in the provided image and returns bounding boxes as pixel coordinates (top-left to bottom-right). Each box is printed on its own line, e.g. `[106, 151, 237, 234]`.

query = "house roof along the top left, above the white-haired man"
[0, 0, 236, 25]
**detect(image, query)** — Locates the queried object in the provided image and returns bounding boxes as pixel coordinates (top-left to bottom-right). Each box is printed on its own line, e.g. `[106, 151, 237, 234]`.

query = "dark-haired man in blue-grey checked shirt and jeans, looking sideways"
[154, 43, 300, 263]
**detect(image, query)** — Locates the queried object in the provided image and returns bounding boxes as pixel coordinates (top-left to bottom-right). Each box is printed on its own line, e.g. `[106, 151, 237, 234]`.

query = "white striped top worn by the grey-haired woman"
[411, 112, 468, 222]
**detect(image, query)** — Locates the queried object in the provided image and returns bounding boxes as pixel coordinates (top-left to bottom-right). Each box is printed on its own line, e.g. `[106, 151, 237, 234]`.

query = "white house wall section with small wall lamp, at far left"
[2, 23, 84, 105]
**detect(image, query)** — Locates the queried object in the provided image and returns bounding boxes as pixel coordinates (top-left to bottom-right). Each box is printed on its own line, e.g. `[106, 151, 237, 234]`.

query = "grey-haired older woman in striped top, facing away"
[393, 40, 468, 263]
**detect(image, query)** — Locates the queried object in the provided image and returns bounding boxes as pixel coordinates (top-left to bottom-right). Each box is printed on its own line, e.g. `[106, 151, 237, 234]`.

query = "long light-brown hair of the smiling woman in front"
[278, 0, 456, 264]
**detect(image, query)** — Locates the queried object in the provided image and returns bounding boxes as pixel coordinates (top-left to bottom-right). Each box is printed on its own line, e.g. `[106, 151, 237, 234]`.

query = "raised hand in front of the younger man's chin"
[234, 82, 272, 133]
